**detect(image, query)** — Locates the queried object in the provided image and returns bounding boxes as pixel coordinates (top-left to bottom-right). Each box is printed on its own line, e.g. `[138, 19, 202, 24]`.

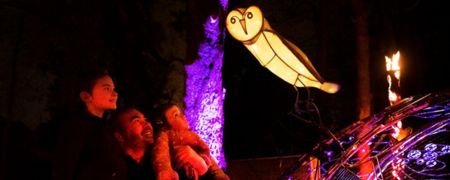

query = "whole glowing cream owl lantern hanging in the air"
[226, 6, 339, 93]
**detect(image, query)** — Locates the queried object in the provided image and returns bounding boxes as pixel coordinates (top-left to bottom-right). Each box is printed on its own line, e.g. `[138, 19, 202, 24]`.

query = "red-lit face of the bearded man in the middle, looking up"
[119, 109, 154, 148]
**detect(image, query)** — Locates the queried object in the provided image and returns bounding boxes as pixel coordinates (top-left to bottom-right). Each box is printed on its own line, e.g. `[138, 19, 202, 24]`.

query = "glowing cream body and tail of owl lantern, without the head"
[245, 28, 339, 93]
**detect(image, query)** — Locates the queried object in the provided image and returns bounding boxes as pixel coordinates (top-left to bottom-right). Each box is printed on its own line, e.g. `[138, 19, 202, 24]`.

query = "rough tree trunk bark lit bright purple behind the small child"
[184, 12, 226, 168]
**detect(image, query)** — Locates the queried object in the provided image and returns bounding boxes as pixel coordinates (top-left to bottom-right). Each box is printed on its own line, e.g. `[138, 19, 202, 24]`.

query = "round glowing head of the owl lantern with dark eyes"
[226, 6, 264, 42]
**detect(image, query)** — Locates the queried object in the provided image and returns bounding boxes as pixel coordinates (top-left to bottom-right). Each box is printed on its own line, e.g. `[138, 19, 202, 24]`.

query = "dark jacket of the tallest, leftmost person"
[53, 112, 128, 180]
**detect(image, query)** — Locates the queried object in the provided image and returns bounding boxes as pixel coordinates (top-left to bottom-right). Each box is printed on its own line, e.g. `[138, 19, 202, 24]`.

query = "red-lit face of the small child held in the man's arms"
[164, 105, 189, 130]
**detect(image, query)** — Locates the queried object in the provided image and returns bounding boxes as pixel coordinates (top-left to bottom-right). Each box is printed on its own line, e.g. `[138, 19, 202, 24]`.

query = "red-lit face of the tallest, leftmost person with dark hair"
[86, 76, 118, 111]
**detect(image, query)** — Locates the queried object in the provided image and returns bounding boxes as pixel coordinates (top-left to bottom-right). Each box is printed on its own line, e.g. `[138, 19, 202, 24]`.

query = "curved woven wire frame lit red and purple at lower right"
[281, 92, 450, 179]
